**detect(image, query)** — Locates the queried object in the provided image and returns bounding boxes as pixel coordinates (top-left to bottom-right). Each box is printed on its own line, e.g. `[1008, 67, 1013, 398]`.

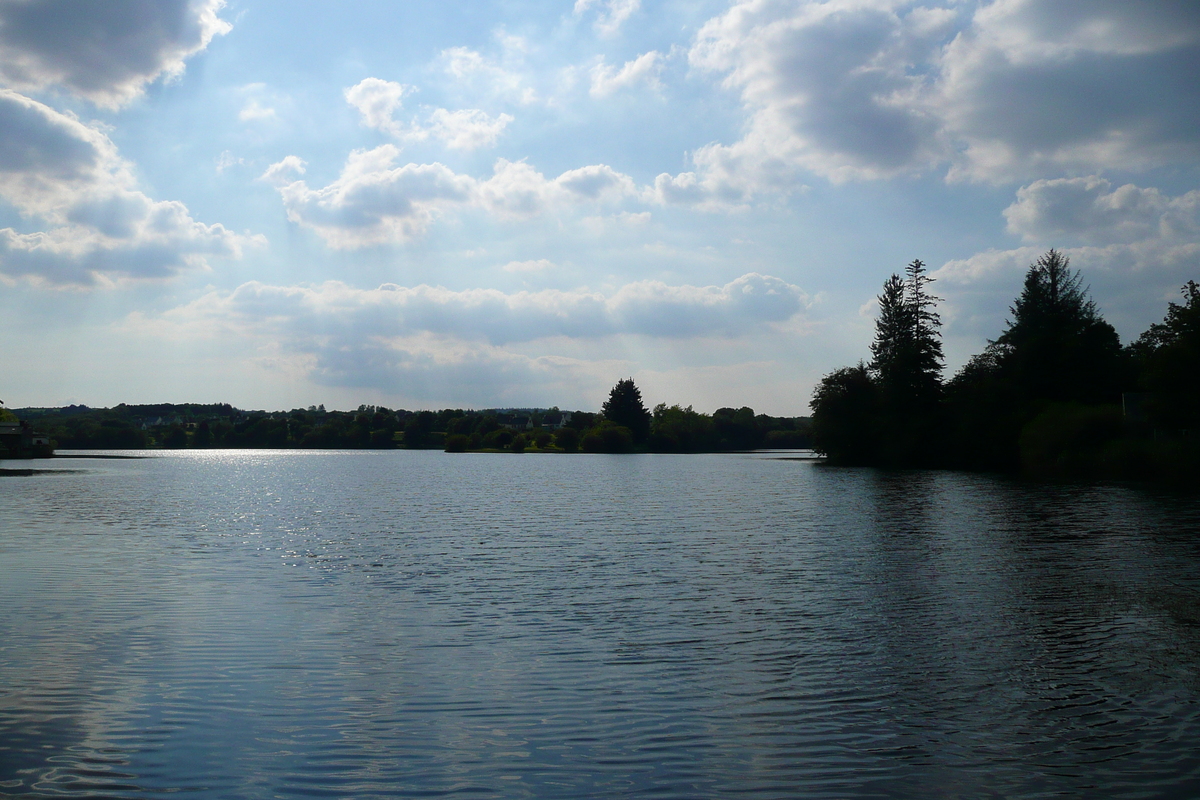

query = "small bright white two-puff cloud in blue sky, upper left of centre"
[346, 78, 512, 150]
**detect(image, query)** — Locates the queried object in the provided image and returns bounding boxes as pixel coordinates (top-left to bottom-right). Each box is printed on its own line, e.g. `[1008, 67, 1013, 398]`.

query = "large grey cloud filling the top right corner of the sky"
[931, 0, 1200, 180]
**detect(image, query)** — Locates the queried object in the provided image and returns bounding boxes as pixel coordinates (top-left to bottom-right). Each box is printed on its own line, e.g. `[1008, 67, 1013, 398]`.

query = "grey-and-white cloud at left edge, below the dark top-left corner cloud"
[0, 90, 247, 285]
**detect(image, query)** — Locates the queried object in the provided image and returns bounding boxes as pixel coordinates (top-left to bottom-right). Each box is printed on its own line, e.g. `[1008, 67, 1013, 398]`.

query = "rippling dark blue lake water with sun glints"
[0, 451, 1200, 798]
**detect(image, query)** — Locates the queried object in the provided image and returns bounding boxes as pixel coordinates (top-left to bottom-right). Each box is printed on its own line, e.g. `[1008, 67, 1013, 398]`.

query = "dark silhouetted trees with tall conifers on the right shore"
[811, 249, 1200, 480]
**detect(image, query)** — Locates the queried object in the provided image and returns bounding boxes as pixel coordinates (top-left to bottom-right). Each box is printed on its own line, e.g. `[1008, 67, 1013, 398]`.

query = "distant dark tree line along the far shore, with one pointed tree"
[9, 391, 810, 452]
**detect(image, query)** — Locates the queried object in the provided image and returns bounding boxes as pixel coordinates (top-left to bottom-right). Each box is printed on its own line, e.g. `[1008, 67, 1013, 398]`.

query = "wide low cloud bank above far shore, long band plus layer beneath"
[125, 273, 808, 403]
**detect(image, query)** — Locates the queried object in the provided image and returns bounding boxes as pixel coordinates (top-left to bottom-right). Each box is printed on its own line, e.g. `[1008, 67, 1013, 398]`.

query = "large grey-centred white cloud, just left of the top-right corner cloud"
[689, 0, 952, 190]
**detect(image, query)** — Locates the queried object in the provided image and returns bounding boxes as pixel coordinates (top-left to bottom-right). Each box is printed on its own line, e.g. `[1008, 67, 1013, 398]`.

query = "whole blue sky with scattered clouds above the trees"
[0, 0, 1200, 415]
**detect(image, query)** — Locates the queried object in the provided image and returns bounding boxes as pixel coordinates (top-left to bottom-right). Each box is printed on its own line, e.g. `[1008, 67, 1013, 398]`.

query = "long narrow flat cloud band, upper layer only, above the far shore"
[145, 272, 809, 345]
